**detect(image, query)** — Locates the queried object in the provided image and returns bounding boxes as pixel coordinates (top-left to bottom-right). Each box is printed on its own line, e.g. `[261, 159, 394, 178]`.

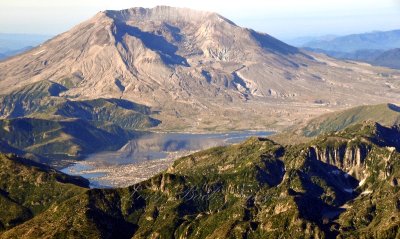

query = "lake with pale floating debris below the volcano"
[61, 131, 273, 188]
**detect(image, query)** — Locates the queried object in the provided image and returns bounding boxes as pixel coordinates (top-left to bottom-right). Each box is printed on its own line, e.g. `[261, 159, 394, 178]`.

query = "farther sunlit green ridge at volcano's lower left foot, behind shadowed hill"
[0, 81, 160, 130]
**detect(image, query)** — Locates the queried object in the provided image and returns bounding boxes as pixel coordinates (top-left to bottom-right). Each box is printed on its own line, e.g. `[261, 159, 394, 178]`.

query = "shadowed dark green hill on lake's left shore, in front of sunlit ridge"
[0, 118, 138, 166]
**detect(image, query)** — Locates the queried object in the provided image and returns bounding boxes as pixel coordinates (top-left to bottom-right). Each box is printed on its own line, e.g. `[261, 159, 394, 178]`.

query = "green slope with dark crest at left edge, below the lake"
[0, 154, 89, 233]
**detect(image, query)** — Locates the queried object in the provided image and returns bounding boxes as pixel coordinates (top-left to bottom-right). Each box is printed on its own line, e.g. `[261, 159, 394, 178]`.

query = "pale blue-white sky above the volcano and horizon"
[0, 0, 400, 39]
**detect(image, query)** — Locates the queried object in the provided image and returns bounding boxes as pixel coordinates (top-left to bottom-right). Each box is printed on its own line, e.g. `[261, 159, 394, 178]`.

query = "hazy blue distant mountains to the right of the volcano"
[292, 30, 400, 69]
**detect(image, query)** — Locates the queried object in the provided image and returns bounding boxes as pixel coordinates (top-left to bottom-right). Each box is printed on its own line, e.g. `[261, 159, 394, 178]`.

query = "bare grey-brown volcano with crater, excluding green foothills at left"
[0, 6, 400, 130]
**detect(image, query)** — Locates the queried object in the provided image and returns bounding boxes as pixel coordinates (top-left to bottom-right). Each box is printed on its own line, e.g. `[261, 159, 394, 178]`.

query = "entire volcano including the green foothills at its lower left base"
[0, 6, 400, 167]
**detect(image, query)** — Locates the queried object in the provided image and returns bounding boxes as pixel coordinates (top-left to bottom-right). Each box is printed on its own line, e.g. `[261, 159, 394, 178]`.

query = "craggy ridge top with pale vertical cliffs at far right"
[306, 122, 400, 198]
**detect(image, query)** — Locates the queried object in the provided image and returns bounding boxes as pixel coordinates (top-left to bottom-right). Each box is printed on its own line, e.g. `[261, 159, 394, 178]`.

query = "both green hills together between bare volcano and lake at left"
[0, 81, 160, 166]
